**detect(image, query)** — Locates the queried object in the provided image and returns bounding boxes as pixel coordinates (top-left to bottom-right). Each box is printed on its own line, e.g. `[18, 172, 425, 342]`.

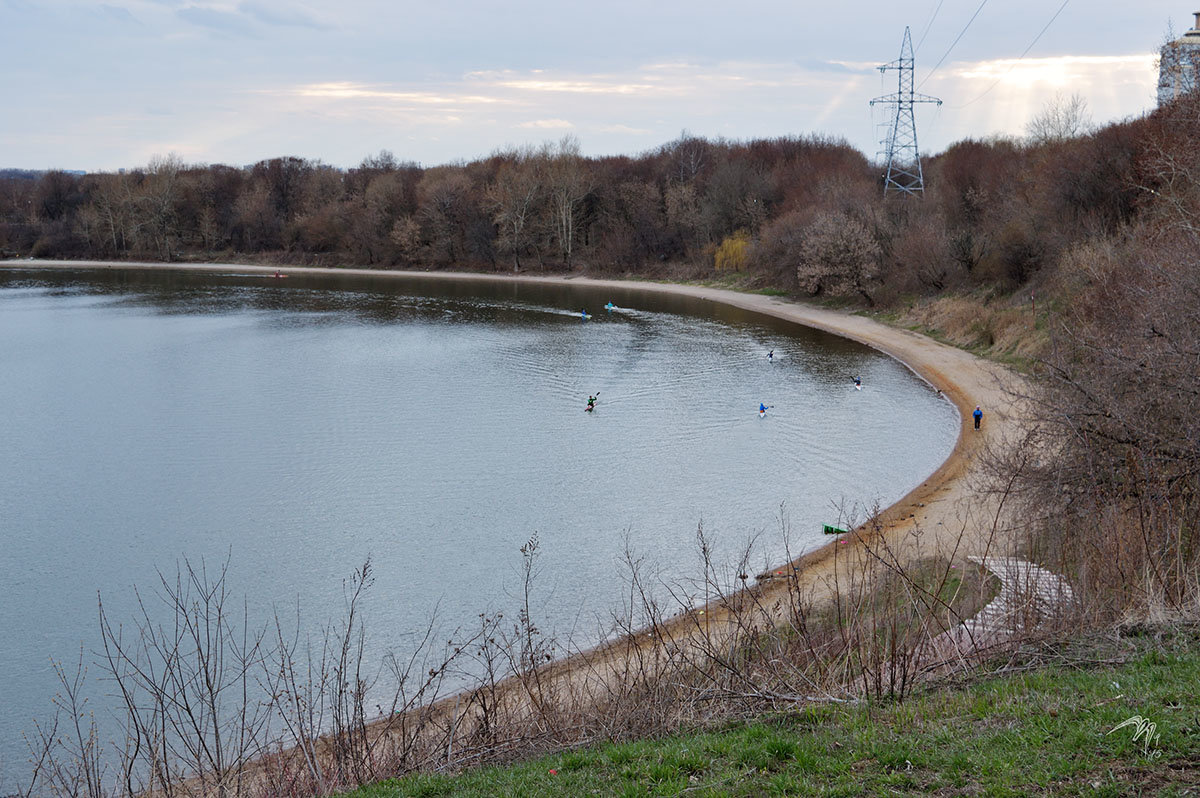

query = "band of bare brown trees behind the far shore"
[0, 103, 1163, 305]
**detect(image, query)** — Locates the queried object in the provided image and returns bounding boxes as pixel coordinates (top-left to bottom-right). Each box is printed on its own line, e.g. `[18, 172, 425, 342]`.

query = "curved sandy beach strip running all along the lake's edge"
[0, 260, 1025, 772]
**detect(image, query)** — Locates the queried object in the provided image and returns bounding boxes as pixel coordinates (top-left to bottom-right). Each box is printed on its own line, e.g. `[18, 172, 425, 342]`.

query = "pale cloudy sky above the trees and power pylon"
[0, 0, 1200, 170]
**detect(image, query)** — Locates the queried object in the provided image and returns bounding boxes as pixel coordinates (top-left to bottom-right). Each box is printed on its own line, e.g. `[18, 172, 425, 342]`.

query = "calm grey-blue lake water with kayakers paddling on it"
[0, 269, 958, 786]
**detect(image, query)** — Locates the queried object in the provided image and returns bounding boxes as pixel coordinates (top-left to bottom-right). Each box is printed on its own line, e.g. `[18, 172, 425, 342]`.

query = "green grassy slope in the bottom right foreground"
[352, 630, 1200, 798]
